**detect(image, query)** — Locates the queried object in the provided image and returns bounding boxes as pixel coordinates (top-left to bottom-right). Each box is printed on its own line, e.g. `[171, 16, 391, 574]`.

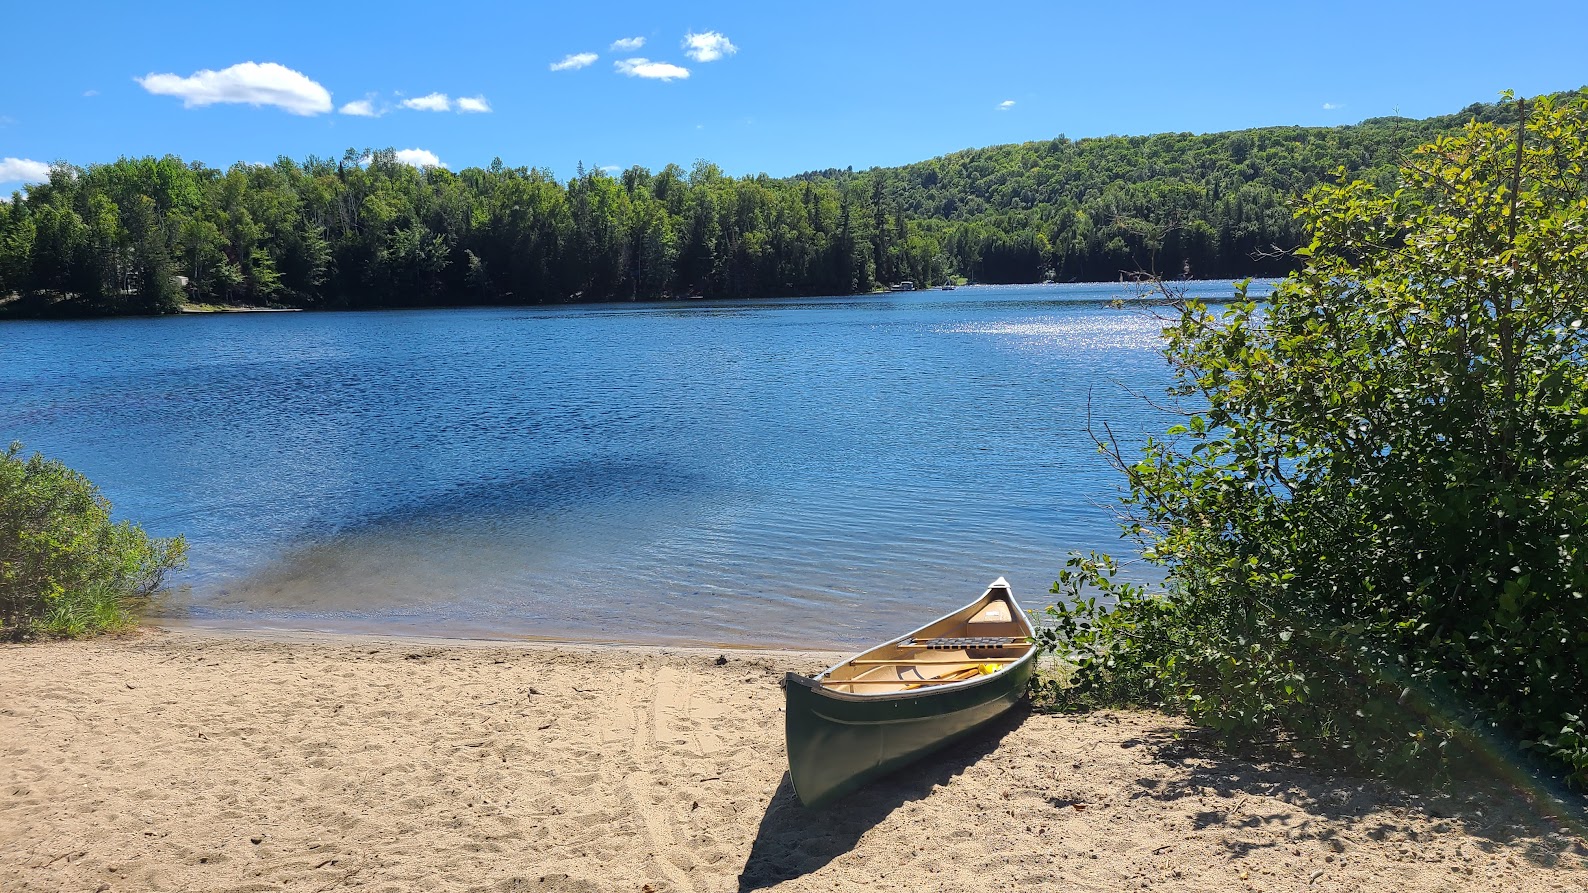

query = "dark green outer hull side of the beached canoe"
[784, 655, 1034, 809]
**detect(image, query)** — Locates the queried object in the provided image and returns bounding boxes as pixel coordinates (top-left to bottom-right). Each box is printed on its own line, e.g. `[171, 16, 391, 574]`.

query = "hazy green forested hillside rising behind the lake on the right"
[800, 96, 1537, 283]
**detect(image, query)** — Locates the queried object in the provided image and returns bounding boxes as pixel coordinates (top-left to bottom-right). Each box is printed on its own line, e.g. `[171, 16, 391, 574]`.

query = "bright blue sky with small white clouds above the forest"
[0, 0, 1588, 191]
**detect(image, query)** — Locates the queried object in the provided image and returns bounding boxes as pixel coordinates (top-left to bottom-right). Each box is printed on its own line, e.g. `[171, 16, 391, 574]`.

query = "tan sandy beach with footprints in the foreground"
[0, 631, 1588, 893]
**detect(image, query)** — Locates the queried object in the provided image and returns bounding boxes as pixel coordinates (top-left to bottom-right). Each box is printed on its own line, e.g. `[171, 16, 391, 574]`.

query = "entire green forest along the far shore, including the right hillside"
[0, 93, 1543, 316]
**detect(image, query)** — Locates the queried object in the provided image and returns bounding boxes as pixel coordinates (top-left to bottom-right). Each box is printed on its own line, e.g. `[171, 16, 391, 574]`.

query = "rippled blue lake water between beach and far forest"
[0, 283, 1251, 647]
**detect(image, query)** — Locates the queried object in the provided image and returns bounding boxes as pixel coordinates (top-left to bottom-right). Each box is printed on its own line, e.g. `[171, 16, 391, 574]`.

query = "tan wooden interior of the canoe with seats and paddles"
[818, 588, 1032, 694]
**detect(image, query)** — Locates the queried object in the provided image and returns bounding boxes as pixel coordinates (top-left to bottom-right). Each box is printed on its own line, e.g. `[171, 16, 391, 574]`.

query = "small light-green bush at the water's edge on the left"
[0, 443, 187, 640]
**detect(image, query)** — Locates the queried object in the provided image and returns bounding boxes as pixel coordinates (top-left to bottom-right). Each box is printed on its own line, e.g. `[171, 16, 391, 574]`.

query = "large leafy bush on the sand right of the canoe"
[1045, 94, 1588, 783]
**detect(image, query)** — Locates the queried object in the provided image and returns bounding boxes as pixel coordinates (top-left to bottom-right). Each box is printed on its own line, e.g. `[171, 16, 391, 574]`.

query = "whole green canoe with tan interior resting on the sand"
[783, 577, 1035, 809]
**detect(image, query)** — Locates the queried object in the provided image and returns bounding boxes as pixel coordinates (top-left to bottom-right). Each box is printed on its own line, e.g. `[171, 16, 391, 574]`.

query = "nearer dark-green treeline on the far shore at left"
[0, 151, 932, 313]
